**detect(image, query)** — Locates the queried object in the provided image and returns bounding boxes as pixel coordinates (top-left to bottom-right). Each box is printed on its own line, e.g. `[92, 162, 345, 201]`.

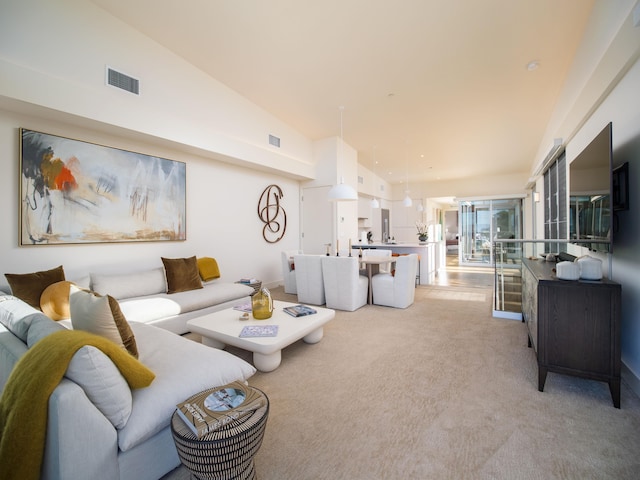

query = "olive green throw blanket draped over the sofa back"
[0, 330, 155, 480]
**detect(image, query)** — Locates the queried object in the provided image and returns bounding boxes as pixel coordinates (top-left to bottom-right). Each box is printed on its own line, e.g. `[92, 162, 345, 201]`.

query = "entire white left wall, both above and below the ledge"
[0, 0, 316, 290]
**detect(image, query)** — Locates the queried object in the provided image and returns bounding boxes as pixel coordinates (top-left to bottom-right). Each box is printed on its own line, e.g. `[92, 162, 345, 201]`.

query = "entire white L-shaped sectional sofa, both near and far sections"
[0, 257, 256, 480]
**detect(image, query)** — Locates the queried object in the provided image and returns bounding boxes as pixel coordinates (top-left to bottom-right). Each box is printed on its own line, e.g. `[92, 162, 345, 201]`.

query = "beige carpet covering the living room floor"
[165, 285, 640, 480]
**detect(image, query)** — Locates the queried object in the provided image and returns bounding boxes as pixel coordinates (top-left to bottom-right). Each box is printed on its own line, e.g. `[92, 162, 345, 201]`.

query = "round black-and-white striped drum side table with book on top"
[171, 387, 269, 480]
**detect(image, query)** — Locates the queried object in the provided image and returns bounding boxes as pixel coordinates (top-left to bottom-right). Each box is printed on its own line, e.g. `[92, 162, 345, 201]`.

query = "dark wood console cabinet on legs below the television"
[522, 259, 621, 408]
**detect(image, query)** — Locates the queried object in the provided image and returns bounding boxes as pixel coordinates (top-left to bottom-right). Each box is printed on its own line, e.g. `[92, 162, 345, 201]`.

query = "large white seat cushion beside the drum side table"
[118, 322, 256, 451]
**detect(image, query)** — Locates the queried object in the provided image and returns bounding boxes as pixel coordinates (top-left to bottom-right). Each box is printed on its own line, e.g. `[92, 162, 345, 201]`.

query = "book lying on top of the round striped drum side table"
[176, 382, 265, 438]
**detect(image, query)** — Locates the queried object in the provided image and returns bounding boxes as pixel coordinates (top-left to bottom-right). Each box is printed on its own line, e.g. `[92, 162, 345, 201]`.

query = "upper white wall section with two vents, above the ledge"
[0, 0, 315, 178]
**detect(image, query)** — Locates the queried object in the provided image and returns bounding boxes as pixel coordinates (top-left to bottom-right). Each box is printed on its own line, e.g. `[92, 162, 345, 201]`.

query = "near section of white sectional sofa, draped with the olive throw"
[0, 295, 256, 480]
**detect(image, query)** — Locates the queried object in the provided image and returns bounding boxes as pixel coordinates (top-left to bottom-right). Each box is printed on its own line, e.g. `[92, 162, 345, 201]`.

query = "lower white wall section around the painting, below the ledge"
[0, 110, 300, 285]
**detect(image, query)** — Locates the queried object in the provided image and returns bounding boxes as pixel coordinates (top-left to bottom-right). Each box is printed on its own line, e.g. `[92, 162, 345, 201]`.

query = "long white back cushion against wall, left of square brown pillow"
[91, 267, 167, 300]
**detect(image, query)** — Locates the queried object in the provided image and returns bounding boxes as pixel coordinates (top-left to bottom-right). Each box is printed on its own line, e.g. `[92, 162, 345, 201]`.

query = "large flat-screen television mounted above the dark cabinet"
[569, 122, 613, 252]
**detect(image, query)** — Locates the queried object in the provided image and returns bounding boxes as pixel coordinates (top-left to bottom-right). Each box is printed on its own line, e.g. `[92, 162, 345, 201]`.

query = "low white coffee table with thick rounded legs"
[187, 301, 336, 372]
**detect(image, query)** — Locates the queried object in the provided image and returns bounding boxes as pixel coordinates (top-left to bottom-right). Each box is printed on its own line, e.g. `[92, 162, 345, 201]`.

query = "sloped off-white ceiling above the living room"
[93, 0, 593, 183]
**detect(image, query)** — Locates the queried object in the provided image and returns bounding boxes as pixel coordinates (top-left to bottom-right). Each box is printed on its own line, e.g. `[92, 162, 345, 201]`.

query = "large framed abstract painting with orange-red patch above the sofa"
[19, 128, 186, 245]
